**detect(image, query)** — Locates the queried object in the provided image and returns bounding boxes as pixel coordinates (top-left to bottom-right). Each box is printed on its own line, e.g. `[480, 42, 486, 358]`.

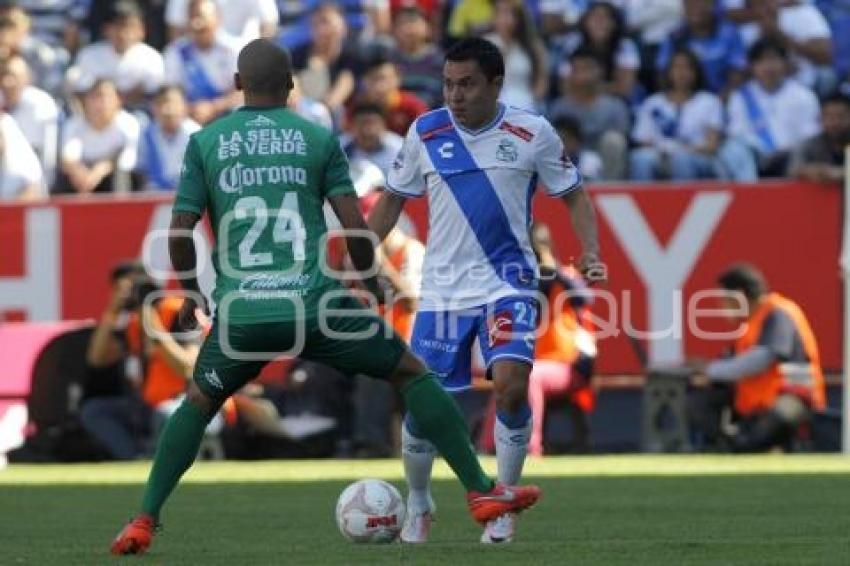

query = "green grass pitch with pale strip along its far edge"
[0, 456, 850, 566]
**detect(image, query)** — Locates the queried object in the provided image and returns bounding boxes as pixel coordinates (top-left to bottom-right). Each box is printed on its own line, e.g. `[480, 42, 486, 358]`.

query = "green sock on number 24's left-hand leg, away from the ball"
[142, 401, 209, 519]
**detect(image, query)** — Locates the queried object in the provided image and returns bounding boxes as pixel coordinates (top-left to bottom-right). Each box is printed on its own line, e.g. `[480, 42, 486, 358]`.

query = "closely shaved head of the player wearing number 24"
[237, 38, 293, 96]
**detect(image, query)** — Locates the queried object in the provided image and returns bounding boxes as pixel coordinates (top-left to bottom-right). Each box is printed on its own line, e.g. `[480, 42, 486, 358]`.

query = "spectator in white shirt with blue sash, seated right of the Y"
[727, 39, 821, 180]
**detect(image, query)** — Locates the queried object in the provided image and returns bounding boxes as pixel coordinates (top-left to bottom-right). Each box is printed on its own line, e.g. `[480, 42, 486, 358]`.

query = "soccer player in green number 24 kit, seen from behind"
[111, 39, 540, 554]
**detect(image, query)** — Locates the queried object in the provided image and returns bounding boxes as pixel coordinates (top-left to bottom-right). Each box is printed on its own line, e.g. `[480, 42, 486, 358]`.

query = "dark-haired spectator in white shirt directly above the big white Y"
[630, 49, 723, 181]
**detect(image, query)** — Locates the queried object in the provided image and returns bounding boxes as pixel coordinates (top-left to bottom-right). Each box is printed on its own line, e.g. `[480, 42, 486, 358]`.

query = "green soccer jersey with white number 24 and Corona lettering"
[174, 107, 355, 323]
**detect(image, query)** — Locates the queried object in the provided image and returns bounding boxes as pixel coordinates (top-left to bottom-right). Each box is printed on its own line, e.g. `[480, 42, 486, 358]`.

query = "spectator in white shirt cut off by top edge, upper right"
[724, 0, 836, 92]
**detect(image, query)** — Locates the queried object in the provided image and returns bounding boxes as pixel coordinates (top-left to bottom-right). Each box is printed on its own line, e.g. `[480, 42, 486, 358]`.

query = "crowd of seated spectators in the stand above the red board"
[0, 0, 850, 200]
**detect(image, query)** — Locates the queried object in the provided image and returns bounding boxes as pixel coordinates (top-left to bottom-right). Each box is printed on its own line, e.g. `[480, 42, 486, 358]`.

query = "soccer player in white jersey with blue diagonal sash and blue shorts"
[369, 38, 604, 543]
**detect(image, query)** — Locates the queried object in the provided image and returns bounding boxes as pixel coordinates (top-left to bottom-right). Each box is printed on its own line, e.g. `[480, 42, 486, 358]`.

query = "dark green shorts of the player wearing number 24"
[193, 296, 407, 401]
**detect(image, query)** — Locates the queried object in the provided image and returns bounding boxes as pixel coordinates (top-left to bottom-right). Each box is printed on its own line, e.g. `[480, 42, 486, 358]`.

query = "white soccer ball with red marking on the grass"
[336, 479, 405, 542]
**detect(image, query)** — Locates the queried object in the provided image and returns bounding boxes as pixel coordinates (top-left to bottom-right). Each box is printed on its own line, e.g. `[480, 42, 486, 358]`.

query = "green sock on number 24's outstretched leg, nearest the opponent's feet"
[402, 372, 493, 492]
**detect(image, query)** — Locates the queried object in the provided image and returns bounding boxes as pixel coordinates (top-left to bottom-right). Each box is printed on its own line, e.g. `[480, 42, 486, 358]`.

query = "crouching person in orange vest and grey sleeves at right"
[691, 264, 826, 452]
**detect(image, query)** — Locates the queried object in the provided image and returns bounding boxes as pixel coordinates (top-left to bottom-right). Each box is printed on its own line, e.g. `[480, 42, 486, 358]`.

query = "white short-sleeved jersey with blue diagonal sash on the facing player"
[387, 105, 581, 311]
